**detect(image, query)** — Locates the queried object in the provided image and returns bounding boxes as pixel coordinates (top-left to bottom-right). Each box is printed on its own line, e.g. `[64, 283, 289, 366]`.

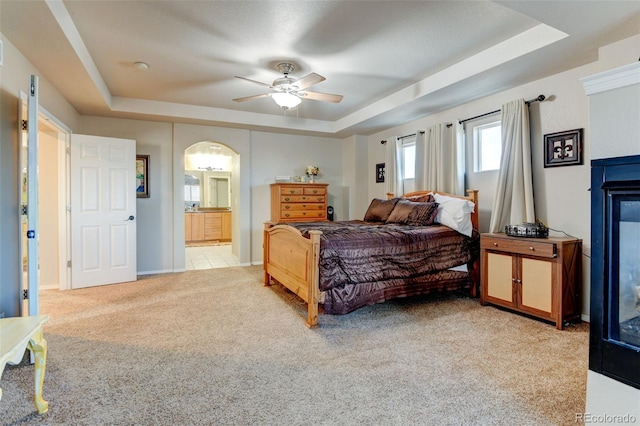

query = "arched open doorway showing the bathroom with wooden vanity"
[184, 142, 239, 270]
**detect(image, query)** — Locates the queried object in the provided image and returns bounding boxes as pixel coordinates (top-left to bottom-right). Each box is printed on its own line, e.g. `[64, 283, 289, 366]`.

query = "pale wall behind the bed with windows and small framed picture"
[368, 35, 640, 321]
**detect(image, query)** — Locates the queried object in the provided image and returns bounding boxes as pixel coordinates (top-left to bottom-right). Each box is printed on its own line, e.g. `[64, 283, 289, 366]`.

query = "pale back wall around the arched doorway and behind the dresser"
[81, 117, 348, 274]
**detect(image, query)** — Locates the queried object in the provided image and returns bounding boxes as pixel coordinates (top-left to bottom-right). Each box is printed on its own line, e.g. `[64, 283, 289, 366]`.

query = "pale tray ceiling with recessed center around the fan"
[0, 0, 640, 137]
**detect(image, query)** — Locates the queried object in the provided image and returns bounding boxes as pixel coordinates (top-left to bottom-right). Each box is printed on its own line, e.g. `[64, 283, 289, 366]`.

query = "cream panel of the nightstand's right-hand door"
[519, 258, 553, 314]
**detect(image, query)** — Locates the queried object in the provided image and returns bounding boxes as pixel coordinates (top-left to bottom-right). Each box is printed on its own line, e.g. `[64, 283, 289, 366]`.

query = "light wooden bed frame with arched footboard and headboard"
[263, 189, 480, 328]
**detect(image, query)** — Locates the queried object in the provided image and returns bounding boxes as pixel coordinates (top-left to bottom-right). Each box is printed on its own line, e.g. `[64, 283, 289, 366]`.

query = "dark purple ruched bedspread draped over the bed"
[287, 220, 478, 313]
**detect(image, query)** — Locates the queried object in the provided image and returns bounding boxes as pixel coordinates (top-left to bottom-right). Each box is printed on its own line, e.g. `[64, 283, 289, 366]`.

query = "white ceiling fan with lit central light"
[233, 62, 342, 110]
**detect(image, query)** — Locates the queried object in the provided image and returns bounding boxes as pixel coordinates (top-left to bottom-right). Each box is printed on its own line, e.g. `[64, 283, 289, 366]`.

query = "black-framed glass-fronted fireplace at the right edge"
[589, 155, 640, 389]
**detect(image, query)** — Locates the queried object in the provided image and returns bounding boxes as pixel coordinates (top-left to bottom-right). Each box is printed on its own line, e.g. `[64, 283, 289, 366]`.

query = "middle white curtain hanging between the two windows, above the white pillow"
[415, 123, 465, 195]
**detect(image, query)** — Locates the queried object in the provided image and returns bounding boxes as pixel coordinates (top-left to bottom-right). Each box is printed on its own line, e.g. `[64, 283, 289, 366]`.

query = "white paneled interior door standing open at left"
[71, 135, 137, 288]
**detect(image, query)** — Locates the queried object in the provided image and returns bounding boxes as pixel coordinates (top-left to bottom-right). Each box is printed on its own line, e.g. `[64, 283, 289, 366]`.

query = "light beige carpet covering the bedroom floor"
[0, 266, 588, 425]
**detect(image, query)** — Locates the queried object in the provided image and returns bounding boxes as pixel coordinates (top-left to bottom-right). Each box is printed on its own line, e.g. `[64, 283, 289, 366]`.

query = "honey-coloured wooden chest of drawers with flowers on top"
[271, 183, 329, 222]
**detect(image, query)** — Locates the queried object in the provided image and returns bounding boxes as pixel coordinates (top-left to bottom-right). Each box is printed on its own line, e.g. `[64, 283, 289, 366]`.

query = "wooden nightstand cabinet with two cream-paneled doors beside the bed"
[480, 234, 582, 330]
